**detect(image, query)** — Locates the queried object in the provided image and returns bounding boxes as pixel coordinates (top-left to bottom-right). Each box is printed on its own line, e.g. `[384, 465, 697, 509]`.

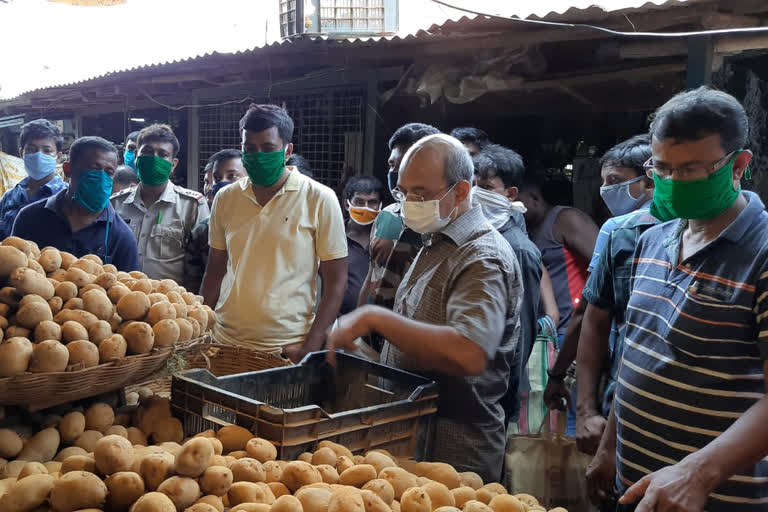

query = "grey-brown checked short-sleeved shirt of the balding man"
[381, 207, 523, 481]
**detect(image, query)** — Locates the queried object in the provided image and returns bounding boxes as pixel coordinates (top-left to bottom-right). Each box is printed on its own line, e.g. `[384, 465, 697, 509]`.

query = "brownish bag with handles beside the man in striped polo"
[503, 414, 597, 512]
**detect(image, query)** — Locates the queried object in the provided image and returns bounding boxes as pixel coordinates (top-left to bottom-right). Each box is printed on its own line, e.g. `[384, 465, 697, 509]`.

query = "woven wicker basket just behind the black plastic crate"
[125, 343, 291, 396]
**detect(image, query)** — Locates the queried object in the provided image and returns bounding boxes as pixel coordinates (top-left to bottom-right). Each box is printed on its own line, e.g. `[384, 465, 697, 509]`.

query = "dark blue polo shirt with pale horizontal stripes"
[614, 192, 768, 512]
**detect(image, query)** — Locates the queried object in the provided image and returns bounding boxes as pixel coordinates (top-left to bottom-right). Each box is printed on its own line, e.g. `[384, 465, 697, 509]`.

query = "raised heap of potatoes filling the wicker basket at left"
[0, 237, 216, 377]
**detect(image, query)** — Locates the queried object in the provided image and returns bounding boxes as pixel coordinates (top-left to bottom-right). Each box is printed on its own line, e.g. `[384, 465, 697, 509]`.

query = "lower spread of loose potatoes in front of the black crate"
[0, 397, 566, 512]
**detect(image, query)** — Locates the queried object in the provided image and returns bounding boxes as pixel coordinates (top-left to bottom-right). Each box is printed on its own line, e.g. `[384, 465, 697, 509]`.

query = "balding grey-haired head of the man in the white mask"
[397, 133, 475, 217]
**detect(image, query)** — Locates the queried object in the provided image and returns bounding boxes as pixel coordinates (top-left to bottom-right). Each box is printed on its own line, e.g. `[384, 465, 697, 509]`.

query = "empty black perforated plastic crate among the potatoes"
[171, 351, 438, 460]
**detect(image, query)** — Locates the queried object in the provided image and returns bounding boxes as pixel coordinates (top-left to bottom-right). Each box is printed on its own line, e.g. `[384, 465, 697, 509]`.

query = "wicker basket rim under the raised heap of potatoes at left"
[0, 349, 173, 411]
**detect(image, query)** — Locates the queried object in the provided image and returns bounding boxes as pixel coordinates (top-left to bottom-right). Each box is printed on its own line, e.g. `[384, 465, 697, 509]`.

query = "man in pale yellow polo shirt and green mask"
[203, 105, 347, 362]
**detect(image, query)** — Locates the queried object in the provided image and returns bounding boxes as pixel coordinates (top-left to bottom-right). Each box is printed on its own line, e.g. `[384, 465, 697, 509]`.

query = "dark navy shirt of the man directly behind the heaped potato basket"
[11, 189, 139, 272]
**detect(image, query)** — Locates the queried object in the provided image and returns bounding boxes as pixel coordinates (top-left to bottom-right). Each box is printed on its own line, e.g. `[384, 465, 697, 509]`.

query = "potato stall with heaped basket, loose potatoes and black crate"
[0, 238, 565, 512]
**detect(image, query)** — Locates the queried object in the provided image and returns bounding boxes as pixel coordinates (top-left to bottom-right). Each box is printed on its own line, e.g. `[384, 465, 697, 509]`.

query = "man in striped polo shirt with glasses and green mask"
[590, 88, 768, 512]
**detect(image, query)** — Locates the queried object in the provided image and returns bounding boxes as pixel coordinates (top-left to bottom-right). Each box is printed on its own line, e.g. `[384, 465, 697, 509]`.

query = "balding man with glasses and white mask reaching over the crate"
[328, 134, 523, 482]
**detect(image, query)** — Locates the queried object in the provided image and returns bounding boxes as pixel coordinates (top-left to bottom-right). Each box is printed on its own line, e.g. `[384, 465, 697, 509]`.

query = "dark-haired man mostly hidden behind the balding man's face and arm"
[358, 123, 440, 350]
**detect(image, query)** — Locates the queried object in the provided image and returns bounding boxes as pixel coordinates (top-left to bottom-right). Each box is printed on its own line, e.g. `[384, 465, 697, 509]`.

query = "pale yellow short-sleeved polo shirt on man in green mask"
[208, 167, 347, 350]
